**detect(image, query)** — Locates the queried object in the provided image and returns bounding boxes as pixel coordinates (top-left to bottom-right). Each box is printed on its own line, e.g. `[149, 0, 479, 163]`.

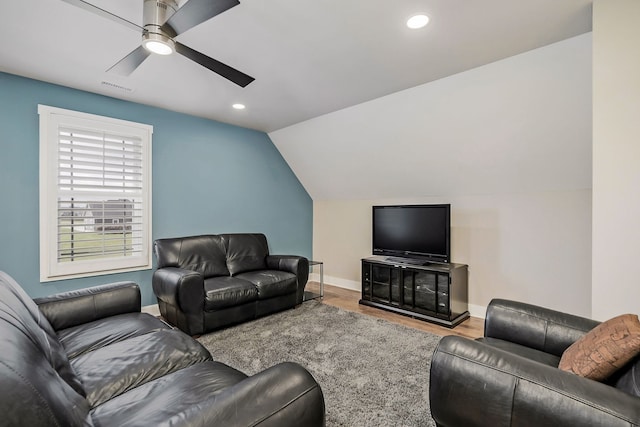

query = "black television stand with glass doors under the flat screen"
[359, 256, 469, 328]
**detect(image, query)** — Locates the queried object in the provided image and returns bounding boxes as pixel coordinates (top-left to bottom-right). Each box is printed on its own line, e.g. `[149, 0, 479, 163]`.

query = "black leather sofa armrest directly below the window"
[34, 282, 141, 330]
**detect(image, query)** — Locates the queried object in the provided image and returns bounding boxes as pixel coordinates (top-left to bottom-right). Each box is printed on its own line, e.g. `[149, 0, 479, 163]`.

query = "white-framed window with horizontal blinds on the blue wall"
[38, 105, 153, 281]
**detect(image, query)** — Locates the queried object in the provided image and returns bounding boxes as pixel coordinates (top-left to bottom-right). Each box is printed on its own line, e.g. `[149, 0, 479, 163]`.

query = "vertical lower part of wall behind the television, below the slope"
[313, 190, 591, 317]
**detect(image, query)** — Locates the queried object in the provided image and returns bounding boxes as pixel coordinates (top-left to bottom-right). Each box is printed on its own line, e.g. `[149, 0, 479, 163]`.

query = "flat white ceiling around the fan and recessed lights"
[0, 0, 592, 132]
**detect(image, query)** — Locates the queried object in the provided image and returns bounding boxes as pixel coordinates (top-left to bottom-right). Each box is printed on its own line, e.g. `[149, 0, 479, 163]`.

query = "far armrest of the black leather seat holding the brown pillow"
[484, 299, 600, 357]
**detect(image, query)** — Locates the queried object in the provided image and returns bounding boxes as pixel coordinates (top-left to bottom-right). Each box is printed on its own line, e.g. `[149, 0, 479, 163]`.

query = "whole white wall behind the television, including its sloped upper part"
[270, 34, 592, 316]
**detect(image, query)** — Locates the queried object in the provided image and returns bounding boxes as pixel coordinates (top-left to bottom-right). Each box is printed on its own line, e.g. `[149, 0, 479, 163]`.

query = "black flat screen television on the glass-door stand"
[373, 204, 451, 262]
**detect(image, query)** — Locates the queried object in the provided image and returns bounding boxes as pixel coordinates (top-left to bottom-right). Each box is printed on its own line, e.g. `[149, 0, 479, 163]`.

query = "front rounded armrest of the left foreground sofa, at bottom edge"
[207, 362, 325, 427]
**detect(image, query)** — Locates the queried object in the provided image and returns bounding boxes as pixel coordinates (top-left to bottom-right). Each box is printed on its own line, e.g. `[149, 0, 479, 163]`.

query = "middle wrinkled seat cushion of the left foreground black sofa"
[71, 329, 211, 407]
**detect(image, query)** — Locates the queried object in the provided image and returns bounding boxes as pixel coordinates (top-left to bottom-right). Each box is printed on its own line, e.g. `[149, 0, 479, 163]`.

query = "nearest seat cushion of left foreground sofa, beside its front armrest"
[91, 362, 247, 426]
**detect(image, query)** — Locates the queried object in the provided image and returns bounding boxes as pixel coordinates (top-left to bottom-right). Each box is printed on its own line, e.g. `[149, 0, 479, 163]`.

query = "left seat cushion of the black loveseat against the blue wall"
[204, 276, 258, 310]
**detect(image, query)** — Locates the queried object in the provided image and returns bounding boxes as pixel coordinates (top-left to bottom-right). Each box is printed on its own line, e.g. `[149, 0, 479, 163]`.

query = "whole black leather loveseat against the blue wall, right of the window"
[153, 233, 309, 335]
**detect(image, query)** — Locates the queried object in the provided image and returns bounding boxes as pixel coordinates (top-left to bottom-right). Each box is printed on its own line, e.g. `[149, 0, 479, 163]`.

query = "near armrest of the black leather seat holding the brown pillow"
[429, 336, 640, 427]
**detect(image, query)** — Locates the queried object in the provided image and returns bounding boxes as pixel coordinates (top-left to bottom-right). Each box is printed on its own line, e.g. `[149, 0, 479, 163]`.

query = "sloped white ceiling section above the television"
[269, 33, 592, 200]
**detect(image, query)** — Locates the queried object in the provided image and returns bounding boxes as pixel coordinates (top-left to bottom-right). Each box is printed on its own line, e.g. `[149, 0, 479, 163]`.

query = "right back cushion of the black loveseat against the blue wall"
[220, 234, 269, 276]
